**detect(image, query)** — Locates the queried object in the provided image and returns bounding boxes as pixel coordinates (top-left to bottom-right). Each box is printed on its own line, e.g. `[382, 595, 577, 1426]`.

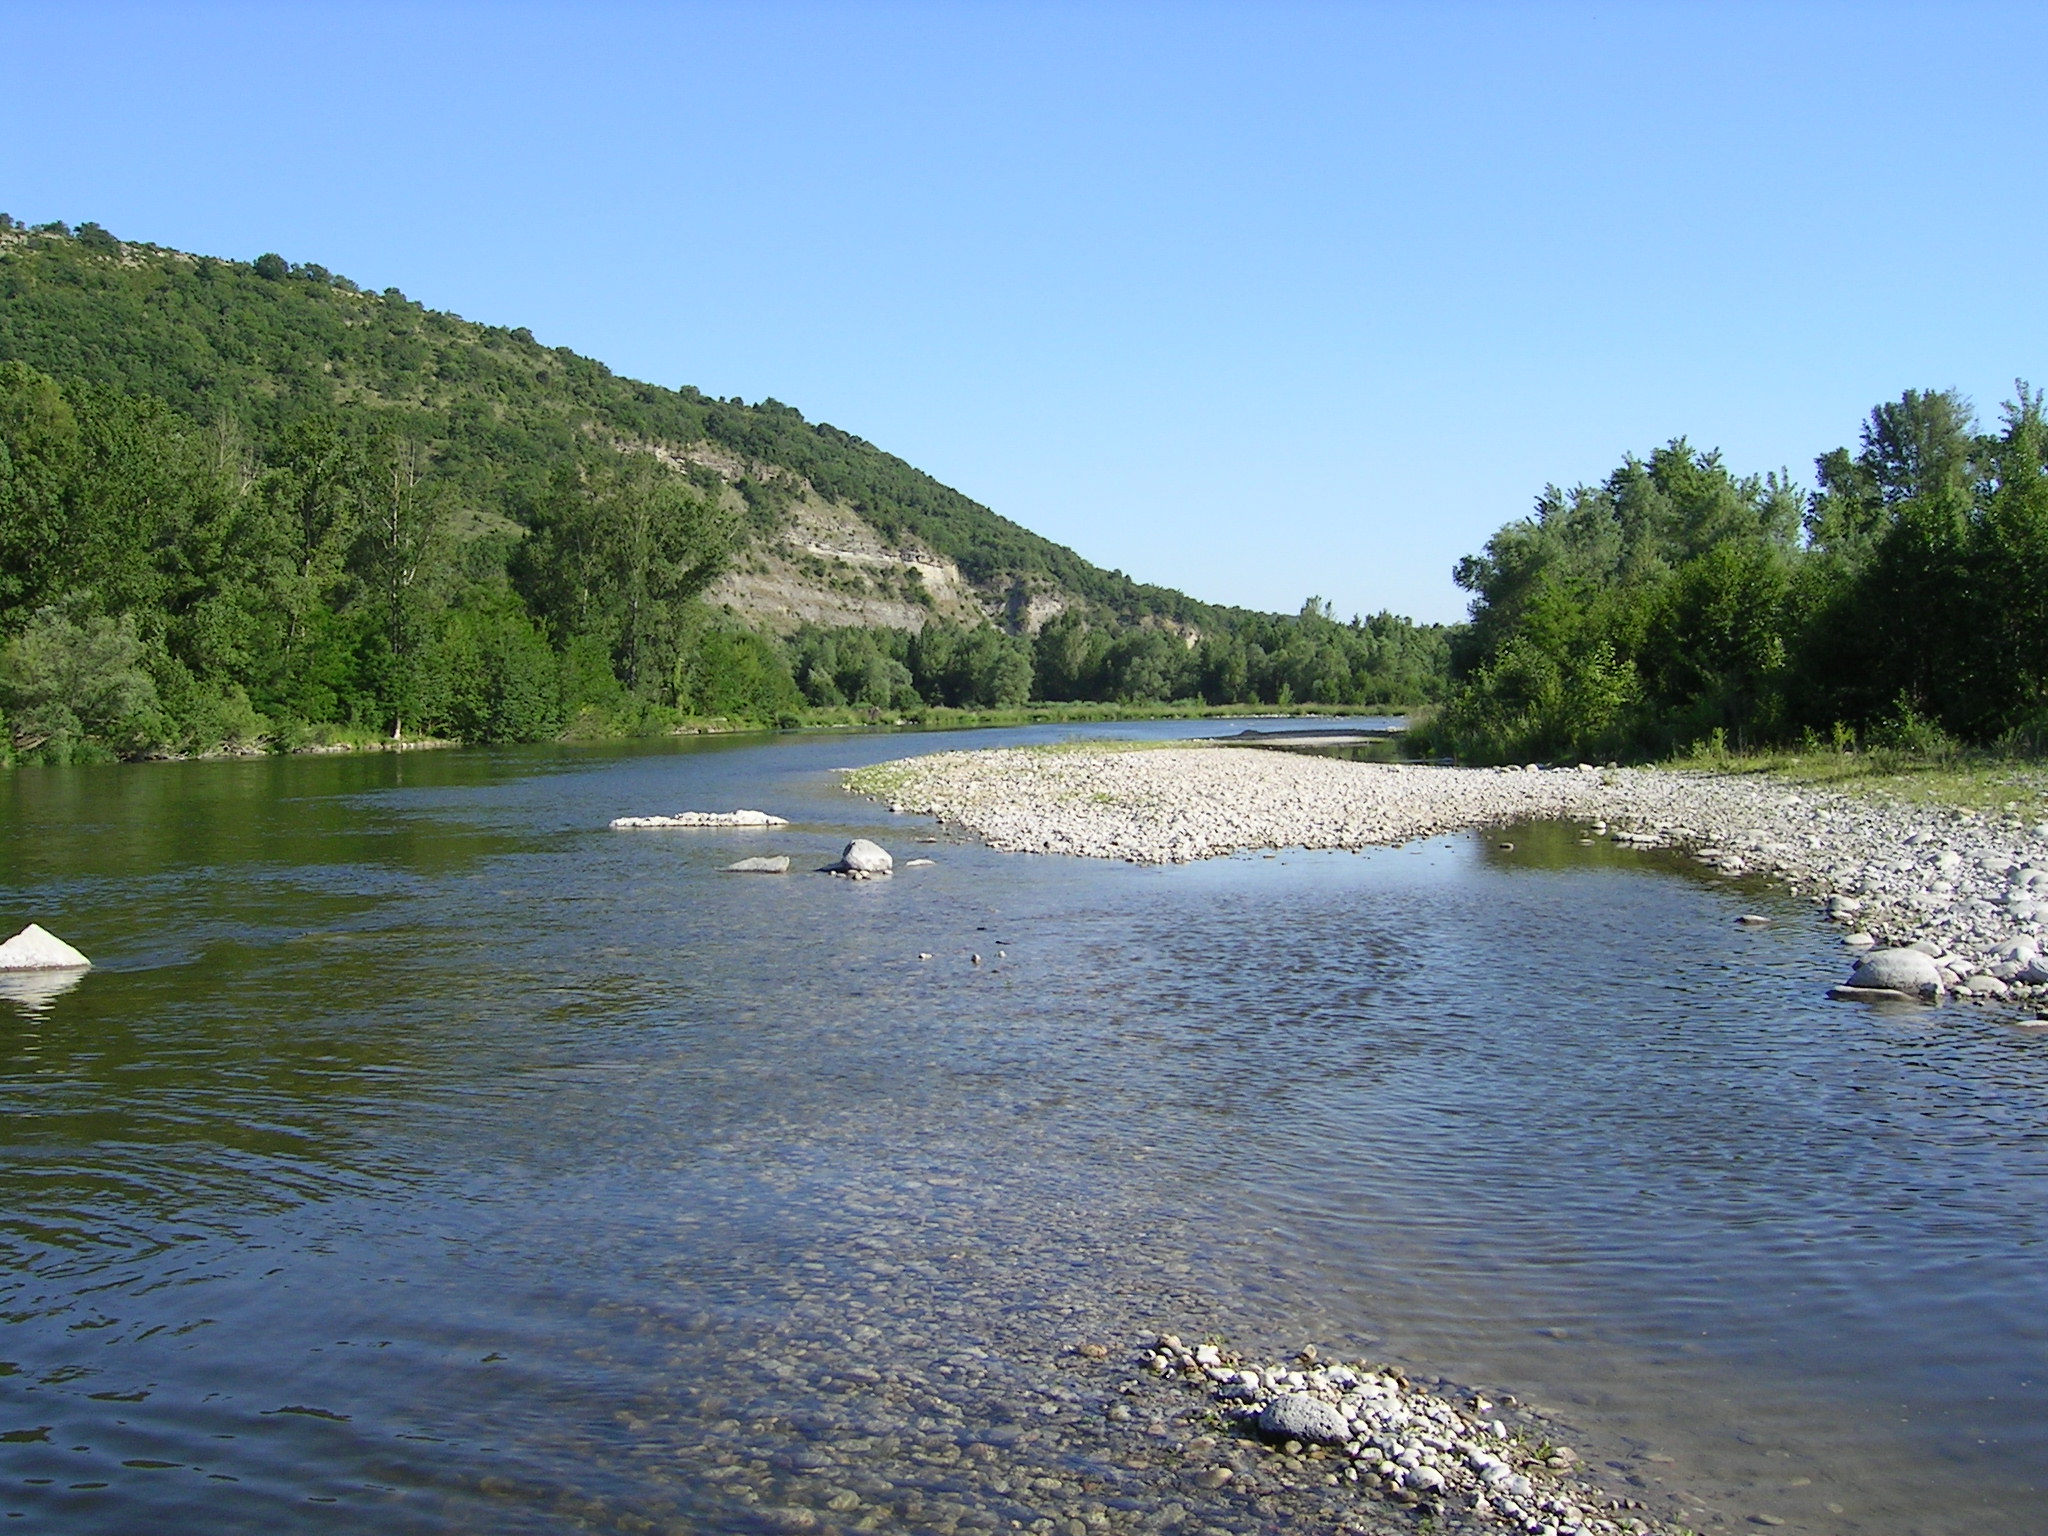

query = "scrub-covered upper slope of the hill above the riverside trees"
[0, 225, 1202, 623]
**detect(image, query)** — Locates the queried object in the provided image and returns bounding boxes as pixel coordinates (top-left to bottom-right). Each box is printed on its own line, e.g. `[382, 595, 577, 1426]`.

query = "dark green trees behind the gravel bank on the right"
[1432, 385, 2048, 762]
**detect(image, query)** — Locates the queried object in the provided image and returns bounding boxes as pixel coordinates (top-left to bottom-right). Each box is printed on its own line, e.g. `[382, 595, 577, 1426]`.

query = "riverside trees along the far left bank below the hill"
[0, 362, 1446, 762]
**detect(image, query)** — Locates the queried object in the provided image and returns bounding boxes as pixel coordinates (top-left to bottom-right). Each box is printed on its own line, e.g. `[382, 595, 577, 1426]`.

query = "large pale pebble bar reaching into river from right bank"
[848, 745, 2048, 1001]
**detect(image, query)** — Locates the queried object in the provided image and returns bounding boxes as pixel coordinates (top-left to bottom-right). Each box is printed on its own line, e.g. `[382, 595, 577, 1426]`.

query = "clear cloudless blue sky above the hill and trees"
[0, 0, 2048, 618]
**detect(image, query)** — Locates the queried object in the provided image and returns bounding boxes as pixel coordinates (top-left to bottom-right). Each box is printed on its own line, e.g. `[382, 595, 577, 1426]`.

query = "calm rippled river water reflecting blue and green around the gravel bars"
[0, 725, 2048, 1534]
